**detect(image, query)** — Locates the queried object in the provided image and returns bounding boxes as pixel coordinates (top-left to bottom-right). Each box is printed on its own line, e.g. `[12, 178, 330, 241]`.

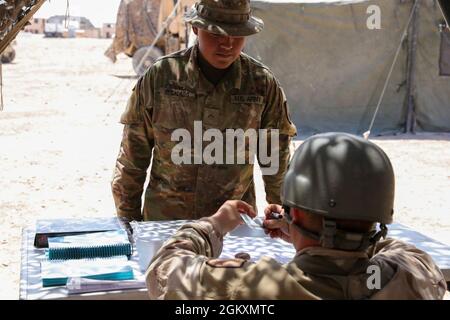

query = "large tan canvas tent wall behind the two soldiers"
[245, 0, 450, 135]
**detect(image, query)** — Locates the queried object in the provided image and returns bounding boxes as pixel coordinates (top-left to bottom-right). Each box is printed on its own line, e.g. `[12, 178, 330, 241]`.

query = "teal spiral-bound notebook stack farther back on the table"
[48, 229, 132, 260]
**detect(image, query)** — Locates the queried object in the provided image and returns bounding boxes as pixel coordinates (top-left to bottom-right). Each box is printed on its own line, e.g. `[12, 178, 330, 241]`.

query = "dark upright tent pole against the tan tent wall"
[405, 0, 420, 133]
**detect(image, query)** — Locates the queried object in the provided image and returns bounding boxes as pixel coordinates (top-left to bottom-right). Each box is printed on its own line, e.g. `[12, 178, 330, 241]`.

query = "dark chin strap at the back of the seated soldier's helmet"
[284, 207, 388, 251]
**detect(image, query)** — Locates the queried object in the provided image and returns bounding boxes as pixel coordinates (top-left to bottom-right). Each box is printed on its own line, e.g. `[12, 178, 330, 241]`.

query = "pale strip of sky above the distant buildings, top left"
[34, 0, 120, 27]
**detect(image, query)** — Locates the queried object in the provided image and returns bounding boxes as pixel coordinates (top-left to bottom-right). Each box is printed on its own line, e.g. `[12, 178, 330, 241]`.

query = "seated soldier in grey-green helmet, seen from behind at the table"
[146, 133, 446, 299]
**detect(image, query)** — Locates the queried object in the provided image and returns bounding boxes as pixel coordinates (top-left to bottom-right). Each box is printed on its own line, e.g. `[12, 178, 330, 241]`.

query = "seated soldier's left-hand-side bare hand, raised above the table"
[210, 200, 256, 235]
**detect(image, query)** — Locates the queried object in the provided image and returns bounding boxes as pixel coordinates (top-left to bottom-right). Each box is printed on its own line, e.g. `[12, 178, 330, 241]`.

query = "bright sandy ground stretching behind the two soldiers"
[0, 33, 450, 299]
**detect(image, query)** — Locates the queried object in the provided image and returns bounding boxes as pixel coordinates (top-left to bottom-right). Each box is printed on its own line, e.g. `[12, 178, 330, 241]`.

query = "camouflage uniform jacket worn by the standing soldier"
[112, 45, 296, 220]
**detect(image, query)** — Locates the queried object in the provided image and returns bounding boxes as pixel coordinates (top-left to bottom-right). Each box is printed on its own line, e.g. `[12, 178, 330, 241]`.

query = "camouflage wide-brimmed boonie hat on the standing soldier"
[184, 0, 264, 37]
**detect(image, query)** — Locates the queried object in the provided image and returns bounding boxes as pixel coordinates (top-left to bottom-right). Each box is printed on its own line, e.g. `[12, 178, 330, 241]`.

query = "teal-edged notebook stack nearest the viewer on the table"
[41, 256, 134, 287]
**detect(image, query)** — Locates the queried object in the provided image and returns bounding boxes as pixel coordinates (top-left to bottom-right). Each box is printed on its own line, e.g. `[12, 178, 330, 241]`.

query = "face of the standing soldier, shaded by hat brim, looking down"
[193, 27, 245, 69]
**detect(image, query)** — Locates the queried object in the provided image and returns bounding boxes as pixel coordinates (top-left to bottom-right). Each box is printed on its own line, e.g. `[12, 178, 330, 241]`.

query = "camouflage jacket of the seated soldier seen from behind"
[146, 219, 446, 300]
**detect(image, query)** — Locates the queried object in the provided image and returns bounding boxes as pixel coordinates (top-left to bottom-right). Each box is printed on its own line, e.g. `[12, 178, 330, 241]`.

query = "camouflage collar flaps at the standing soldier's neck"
[186, 44, 242, 90]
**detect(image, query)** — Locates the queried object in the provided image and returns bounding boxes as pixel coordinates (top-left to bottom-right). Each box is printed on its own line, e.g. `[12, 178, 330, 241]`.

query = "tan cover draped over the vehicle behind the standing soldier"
[105, 0, 161, 62]
